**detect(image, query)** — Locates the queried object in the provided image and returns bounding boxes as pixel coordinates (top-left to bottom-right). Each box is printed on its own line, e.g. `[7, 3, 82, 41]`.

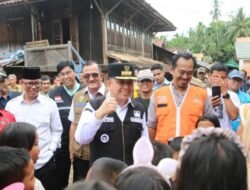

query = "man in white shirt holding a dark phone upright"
[207, 63, 240, 128]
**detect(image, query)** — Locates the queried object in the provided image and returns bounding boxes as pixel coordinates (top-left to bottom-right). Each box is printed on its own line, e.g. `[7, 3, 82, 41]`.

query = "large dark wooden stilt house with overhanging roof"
[0, 0, 176, 70]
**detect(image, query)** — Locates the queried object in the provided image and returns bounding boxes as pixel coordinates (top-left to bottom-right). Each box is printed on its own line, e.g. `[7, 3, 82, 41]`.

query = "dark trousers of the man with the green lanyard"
[55, 149, 71, 189]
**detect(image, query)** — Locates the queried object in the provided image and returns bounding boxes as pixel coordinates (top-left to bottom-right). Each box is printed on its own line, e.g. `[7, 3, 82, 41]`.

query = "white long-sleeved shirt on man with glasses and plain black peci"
[5, 95, 63, 169]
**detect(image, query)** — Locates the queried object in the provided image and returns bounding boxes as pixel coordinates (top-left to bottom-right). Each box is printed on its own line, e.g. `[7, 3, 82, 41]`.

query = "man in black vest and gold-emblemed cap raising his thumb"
[75, 63, 148, 164]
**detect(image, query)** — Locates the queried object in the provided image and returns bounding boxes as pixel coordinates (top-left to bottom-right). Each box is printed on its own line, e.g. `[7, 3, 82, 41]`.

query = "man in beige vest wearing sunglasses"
[68, 61, 107, 181]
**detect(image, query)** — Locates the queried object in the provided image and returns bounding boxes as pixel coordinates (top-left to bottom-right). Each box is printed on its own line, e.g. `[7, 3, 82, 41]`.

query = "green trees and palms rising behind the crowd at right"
[156, 6, 250, 62]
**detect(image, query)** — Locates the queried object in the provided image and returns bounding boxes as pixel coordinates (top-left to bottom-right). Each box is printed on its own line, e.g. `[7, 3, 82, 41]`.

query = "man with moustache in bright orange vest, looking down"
[148, 53, 213, 143]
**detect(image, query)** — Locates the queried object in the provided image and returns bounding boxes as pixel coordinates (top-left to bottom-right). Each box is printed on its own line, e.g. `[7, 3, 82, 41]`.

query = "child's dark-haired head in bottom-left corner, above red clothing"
[0, 146, 35, 190]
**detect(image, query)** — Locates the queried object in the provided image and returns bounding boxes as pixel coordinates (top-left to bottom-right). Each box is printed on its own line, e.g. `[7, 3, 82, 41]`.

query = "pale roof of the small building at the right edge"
[235, 38, 250, 59]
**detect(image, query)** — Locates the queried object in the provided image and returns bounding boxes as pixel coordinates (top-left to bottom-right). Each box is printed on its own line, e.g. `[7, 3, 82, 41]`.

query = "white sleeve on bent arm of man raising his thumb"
[75, 103, 102, 144]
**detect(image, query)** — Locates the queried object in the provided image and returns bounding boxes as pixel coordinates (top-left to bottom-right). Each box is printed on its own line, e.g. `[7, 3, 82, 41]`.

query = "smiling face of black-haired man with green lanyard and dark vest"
[58, 66, 76, 89]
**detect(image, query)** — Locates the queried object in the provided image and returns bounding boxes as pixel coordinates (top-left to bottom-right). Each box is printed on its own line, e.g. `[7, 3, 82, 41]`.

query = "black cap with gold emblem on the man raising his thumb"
[108, 63, 137, 80]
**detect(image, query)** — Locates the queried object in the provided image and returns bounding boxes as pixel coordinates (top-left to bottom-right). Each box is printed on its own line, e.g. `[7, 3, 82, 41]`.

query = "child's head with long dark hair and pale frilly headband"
[176, 127, 247, 190]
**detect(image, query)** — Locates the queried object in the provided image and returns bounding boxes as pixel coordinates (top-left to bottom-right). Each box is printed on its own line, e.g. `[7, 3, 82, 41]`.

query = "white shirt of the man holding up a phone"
[207, 88, 240, 129]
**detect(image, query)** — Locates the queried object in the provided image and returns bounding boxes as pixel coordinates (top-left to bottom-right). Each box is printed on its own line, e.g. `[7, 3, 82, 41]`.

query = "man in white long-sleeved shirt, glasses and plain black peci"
[6, 67, 62, 190]
